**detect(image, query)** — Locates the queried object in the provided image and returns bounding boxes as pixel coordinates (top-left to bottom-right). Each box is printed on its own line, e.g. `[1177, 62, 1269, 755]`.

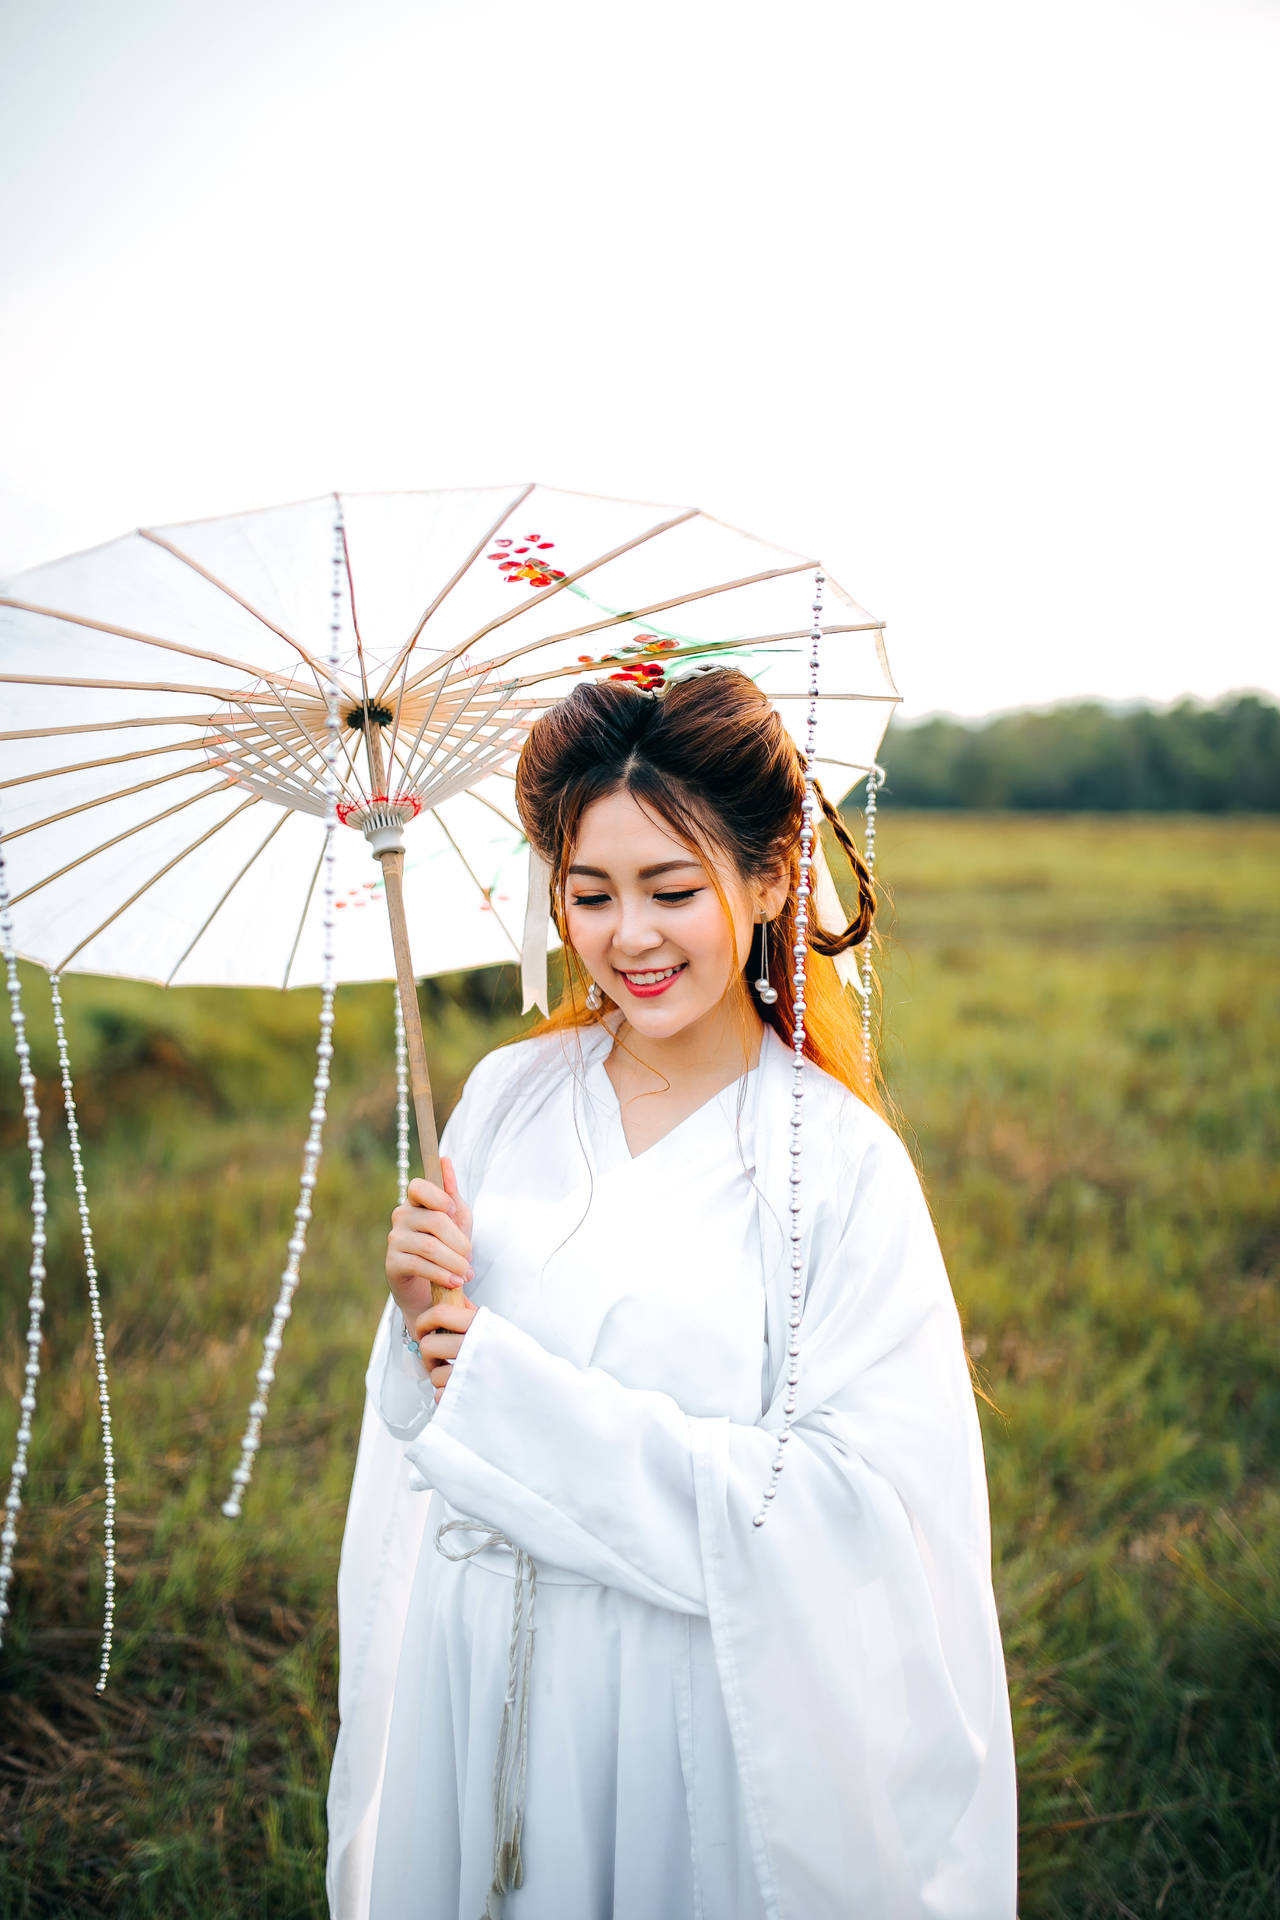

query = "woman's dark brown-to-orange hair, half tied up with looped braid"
[516, 666, 885, 1114]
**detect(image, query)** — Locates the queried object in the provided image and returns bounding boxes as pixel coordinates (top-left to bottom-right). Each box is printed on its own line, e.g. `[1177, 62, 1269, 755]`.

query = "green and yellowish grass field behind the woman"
[0, 810, 1280, 1920]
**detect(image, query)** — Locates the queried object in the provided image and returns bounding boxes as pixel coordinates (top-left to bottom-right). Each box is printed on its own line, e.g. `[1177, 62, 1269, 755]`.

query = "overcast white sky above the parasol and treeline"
[0, 0, 1280, 714]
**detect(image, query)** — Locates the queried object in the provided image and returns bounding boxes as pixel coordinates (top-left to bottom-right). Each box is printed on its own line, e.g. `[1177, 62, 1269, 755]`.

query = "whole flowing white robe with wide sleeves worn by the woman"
[328, 1029, 1017, 1920]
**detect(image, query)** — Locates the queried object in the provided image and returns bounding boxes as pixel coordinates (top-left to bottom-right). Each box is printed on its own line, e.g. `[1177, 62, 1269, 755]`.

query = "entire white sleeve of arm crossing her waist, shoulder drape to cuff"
[395, 1129, 1015, 1920]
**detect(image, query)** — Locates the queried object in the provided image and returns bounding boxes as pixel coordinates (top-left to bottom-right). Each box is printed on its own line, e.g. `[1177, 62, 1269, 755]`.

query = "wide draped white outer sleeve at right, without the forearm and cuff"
[695, 1127, 1017, 1920]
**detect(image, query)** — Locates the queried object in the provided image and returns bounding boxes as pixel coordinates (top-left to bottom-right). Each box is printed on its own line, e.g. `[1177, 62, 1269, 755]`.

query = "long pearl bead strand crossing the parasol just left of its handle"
[223, 501, 345, 1521]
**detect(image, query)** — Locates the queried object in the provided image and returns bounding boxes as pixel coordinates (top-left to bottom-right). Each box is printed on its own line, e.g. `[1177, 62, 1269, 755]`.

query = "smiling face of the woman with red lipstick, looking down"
[564, 793, 785, 1039]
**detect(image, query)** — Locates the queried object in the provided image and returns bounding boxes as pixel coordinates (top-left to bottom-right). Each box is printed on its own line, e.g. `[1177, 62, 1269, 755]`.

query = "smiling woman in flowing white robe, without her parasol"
[328, 668, 1015, 1920]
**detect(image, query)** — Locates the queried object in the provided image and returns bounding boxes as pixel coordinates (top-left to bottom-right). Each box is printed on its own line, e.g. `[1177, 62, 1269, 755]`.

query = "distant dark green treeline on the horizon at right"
[881, 693, 1280, 814]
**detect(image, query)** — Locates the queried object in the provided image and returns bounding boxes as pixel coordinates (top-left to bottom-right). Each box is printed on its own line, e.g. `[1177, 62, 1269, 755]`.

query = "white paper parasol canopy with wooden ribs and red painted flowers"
[0, 486, 896, 987]
